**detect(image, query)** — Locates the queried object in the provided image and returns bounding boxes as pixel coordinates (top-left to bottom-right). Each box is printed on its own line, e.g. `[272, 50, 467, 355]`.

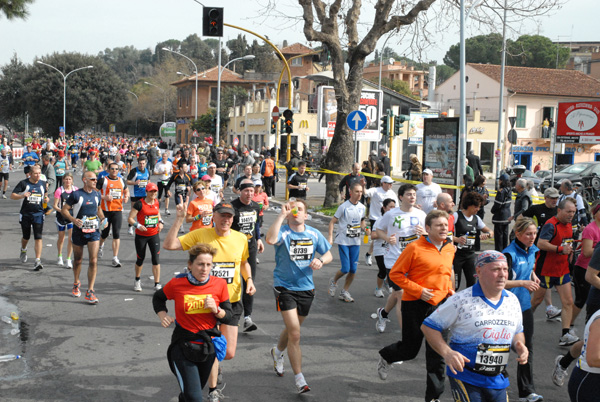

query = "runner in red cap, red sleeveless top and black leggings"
[127, 183, 164, 292]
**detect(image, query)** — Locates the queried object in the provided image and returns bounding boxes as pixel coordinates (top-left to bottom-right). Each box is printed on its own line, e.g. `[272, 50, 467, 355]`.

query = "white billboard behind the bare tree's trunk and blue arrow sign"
[317, 86, 383, 141]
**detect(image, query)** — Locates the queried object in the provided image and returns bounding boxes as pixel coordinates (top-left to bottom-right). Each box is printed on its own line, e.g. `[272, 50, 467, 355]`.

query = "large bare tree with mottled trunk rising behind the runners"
[290, 0, 563, 206]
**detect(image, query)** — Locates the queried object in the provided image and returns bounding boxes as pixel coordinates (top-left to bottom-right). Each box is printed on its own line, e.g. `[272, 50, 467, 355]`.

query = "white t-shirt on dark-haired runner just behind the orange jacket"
[377, 207, 427, 269]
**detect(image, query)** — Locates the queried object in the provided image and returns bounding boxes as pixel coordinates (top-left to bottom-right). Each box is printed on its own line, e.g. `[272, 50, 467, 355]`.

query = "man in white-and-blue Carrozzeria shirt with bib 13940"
[421, 250, 528, 402]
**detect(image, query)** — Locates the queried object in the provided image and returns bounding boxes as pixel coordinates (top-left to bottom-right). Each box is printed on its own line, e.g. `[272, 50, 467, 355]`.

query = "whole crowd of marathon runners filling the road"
[5, 136, 600, 402]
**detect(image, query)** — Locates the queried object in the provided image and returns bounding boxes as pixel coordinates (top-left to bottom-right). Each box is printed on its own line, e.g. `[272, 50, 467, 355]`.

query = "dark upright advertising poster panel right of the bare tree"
[423, 117, 459, 184]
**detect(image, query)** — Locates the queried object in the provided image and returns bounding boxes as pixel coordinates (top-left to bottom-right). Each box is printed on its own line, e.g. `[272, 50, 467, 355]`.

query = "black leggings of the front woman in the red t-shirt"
[167, 344, 215, 402]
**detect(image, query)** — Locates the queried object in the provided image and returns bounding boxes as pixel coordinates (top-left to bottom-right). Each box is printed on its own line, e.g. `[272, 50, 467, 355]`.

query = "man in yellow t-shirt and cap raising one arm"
[163, 200, 256, 402]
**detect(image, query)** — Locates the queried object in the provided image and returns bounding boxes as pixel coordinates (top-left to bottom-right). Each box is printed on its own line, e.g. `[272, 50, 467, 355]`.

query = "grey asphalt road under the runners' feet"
[0, 172, 583, 402]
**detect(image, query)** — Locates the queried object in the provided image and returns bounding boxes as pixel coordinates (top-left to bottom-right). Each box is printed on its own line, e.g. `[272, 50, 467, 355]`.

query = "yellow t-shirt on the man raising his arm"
[179, 228, 249, 303]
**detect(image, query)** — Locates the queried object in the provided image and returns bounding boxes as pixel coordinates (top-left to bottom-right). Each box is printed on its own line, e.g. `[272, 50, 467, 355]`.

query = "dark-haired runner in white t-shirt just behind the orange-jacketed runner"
[376, 184, 427, 332]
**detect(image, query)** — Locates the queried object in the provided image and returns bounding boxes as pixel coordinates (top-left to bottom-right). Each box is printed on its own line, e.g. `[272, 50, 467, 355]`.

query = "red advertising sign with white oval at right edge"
[556, 101, 600, 144]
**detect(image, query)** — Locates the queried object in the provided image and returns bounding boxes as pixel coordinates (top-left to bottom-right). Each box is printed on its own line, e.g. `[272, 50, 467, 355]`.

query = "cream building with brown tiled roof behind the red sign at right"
[434, 63, 600, 169]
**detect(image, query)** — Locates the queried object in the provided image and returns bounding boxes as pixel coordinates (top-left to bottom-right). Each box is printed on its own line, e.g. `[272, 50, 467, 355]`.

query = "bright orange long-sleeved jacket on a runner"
[390, 236, 455, 306]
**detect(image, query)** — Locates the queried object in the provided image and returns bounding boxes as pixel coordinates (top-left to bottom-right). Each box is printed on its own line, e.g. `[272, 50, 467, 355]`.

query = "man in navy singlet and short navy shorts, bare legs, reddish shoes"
[61, 171, 107, 304]
